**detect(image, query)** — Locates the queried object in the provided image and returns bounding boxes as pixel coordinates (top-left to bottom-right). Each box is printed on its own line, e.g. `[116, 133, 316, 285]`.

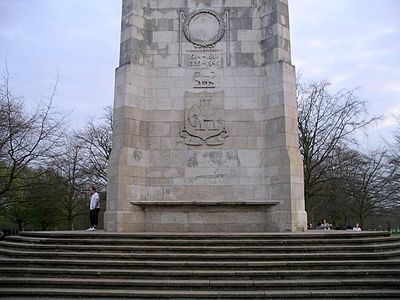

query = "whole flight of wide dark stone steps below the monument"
[0, 231, 400, 299]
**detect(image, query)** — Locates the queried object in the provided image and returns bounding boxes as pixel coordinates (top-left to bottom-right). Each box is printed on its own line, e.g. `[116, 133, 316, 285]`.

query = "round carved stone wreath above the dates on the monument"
[183, 9, 225, 48]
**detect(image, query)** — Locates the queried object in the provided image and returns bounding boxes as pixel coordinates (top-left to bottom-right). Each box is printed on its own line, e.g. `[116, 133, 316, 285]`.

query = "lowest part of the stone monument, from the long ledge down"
[106, 201, 306, 232]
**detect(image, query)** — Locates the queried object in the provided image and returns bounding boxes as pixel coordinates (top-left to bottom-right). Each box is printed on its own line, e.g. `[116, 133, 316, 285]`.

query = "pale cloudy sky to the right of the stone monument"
[289, 0, 400, 147]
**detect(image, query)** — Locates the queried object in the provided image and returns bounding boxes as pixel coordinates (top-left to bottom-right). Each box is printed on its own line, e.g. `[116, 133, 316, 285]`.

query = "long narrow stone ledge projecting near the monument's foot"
[130, 201, 280, 206]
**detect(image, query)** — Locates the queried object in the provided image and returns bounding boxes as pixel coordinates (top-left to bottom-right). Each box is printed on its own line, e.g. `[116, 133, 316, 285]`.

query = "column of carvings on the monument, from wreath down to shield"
[179, 9, 230, 146]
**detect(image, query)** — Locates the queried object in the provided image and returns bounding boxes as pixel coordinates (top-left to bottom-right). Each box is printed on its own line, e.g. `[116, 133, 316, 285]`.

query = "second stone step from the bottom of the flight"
[0, 277, 400, 291]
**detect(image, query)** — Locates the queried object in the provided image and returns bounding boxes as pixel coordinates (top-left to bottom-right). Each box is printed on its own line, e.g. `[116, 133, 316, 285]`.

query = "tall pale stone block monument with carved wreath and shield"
[105, 0, 306, 232]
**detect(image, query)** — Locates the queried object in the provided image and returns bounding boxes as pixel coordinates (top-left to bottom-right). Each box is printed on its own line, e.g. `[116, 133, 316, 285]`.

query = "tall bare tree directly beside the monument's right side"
[297, 81, 378, 221]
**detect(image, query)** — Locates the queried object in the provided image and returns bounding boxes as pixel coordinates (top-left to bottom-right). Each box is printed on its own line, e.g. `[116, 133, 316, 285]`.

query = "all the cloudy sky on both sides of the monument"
[0, 0, 400, 145]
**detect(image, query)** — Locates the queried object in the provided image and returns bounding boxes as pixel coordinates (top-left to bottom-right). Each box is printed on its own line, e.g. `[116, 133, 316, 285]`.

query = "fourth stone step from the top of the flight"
[0, 244, 400, 261]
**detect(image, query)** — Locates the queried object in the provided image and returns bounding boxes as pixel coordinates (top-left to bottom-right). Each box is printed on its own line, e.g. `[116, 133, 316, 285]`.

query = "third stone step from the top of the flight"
[2, 241, 400, 253]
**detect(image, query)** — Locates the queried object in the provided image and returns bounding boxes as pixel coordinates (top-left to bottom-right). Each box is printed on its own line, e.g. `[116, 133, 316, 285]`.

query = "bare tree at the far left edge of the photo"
[0, 64, 65, 210]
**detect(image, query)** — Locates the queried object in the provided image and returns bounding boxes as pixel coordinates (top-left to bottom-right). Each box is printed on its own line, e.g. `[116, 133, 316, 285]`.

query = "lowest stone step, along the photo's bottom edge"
[0, 288, 400, 299]
